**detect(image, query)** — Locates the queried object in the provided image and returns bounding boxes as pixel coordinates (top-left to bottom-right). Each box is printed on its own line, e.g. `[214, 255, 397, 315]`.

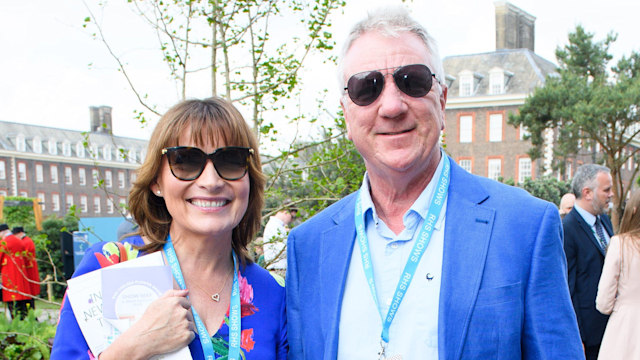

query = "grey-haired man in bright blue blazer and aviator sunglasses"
[287, 9, 583, 360]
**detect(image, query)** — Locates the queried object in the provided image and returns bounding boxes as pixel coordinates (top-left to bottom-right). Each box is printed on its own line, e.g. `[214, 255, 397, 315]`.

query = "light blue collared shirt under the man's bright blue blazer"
[338, 154, 447, 360]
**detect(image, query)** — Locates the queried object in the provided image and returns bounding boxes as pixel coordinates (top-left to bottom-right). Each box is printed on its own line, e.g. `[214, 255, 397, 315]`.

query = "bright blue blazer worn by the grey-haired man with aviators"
[286, 161, 584, 360]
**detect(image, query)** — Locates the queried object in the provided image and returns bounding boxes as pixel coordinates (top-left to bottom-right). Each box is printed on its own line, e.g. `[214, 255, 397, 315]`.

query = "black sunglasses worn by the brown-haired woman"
[162, 146, 253, 181]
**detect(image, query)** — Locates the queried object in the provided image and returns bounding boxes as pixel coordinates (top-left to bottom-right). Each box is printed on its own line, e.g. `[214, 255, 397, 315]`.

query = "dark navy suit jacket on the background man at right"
[562, 208, 613, 346]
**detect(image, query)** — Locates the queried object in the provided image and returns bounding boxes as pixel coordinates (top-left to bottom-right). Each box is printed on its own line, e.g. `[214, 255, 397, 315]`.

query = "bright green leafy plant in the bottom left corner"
[0, 310, 56, 360]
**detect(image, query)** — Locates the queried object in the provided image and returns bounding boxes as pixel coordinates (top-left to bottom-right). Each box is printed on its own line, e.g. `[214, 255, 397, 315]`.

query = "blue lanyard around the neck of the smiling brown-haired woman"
[164, 235, 241, 360]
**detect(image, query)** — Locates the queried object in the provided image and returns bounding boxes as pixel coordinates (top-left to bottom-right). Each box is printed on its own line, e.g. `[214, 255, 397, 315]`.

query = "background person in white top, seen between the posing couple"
[262, 208, 297, 276]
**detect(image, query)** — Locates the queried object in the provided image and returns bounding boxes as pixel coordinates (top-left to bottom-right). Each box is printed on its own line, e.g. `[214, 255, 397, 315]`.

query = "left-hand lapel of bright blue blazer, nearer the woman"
[318, 192, 358, 359]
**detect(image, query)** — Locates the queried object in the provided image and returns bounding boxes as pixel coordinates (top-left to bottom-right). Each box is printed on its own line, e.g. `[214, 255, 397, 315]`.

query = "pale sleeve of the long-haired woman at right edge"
[596, 236, 620, 315]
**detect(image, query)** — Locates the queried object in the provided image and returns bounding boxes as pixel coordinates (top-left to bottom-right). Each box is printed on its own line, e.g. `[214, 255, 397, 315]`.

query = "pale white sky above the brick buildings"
[0, 0, 640, 143]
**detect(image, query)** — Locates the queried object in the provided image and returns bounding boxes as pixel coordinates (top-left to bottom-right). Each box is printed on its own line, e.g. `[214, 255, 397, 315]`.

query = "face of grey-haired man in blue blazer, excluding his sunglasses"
[340, 32, 447, 179]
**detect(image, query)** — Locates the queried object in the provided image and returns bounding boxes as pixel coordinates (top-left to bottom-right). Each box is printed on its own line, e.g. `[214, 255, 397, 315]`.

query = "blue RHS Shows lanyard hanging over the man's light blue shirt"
[355, 156, 450, 348]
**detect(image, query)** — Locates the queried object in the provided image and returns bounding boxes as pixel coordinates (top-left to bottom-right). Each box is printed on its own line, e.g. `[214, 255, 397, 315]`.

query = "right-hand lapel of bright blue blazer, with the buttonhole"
[438, 161, 495, 359]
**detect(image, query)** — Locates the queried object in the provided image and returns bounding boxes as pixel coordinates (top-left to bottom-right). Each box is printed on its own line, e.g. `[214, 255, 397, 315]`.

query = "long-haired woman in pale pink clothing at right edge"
[596, 190, 640, 359]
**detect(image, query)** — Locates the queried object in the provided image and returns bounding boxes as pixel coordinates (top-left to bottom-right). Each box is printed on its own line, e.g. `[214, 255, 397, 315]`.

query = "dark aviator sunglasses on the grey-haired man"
[344, 64, 440, 106]
